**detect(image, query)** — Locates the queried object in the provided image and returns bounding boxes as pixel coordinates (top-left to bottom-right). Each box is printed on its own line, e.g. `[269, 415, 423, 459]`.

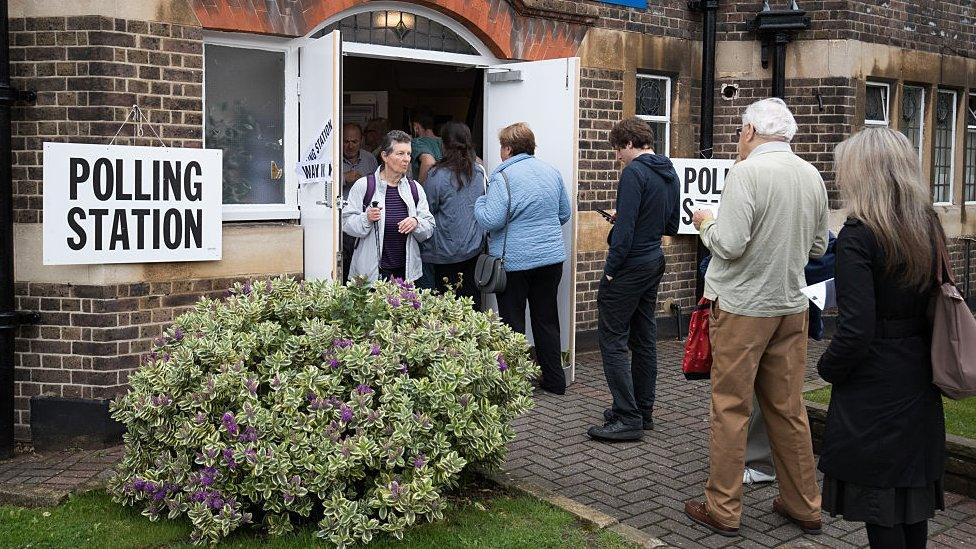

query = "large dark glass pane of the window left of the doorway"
[204, 45, 285, 204]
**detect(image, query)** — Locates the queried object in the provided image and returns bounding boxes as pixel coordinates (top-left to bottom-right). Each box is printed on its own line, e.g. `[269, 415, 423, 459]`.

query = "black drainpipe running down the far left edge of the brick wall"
[0, 0, 34, 459]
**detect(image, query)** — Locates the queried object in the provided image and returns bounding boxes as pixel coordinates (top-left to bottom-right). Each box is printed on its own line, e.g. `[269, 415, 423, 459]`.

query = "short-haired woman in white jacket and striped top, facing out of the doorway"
[342, 130, 434, 282]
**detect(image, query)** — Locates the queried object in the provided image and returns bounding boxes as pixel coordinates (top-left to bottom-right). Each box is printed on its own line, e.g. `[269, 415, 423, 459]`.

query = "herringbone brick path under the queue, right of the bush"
[505, 341, 976, 548]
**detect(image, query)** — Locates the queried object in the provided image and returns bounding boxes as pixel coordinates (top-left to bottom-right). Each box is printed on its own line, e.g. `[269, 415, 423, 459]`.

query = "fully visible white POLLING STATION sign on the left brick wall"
[43, 143, 223, 265]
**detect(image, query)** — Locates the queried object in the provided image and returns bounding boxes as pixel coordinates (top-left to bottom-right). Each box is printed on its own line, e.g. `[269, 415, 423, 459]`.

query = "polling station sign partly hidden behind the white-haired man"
[671, 158, 735, 234]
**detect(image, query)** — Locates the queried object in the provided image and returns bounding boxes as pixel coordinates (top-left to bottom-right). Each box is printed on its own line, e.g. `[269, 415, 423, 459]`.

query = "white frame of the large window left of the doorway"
[203, 32, 299, 221]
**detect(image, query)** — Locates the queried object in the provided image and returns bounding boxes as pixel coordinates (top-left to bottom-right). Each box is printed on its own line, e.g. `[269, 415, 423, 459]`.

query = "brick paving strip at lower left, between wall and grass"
[0, 446, 123, 506]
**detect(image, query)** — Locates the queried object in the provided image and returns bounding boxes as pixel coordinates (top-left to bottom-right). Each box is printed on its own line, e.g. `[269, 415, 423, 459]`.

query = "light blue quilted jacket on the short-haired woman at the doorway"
[474, 154, 572, 271]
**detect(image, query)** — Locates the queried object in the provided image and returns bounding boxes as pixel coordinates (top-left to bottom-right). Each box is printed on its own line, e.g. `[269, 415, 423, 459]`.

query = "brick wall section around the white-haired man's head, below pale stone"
[715, 78, 857, 208]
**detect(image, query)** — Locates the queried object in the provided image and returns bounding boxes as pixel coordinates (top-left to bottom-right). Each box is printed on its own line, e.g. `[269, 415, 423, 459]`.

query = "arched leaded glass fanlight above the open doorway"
[312, 10, 478, 55]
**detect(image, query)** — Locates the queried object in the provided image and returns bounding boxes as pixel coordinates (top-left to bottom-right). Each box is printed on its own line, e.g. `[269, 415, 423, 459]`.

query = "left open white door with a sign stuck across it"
[298, 31, 342, 280]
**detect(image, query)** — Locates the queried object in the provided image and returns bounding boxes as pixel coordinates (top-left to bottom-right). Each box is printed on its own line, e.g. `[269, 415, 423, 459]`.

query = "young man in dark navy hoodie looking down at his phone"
[587, 117, 681, 441]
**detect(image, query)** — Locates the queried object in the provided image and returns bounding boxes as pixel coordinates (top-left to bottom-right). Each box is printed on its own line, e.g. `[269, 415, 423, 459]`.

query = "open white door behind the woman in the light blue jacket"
[484, 57, 580, 381]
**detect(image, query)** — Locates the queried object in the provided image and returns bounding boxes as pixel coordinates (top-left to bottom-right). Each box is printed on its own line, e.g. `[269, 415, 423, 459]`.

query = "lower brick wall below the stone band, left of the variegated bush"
[14, 275, 297, 440]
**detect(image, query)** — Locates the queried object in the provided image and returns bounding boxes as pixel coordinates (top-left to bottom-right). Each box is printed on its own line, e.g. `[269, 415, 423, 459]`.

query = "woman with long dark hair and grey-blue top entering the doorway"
[420, 122, 485, 310]
